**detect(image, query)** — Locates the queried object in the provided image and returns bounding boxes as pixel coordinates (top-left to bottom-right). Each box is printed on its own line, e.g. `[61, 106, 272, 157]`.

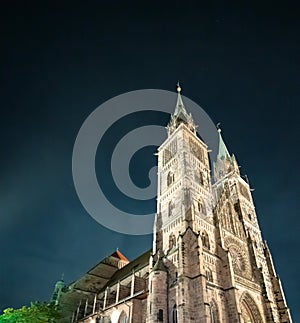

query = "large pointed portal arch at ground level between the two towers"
[240, 292, 263, 323]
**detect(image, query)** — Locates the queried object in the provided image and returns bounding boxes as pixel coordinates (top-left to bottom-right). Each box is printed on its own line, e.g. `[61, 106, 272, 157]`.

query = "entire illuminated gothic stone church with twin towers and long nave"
[53, 85, 292, 323]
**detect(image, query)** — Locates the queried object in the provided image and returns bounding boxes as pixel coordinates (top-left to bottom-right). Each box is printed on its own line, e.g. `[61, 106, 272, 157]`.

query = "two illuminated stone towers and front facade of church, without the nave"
[146, 85, 291, 323]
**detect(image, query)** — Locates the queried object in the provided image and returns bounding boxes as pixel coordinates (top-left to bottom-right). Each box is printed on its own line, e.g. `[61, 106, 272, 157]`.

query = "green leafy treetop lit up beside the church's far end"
[0, 302, 61, 323]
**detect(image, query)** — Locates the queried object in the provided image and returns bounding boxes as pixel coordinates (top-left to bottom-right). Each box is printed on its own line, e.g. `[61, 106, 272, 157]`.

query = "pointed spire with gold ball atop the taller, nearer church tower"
[167, 82, 196, 135]
